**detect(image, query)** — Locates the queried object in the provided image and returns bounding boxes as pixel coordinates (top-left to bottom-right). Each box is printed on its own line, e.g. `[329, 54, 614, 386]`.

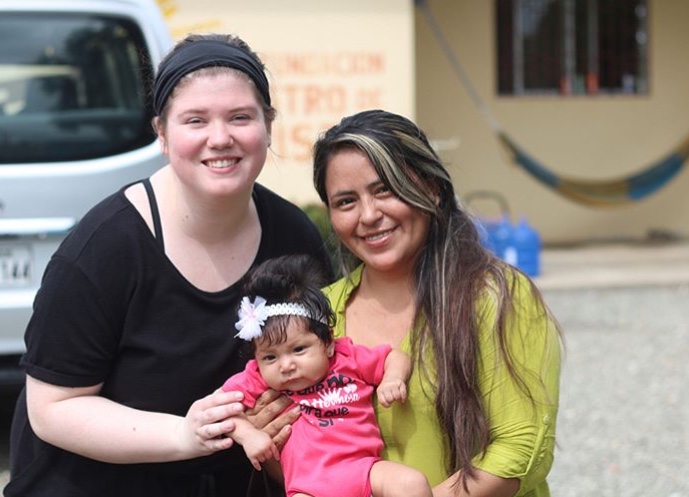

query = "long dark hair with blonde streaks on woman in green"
[314, 110, 560, 488]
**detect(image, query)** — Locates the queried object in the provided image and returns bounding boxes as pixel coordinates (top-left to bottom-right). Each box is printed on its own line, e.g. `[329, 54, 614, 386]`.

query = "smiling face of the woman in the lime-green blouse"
[325, 148, 429, 275]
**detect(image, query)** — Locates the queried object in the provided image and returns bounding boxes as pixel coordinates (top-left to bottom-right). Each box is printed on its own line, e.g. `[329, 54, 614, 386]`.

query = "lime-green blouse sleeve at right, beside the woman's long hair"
[474, 275, 560, 497]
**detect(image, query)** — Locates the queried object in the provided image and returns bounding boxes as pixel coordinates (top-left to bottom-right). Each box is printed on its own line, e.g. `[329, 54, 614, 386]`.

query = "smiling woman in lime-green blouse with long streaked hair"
[314, 110, 561, 497]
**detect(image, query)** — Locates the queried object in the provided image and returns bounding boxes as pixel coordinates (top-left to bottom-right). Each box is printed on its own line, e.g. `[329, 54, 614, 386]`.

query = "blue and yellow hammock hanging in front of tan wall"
[416, 0, 689, 207]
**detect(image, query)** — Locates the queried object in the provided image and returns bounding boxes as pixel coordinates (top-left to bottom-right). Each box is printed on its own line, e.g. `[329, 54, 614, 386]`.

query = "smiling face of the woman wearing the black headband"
[158, 68, 271, 200]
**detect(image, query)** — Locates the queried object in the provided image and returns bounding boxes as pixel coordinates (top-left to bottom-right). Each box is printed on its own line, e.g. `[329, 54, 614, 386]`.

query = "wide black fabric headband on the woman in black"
[153, 40, 270, 116]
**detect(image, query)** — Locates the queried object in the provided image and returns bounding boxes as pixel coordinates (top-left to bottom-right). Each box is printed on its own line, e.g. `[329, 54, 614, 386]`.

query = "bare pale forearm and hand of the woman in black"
[26, 376, 243, 464]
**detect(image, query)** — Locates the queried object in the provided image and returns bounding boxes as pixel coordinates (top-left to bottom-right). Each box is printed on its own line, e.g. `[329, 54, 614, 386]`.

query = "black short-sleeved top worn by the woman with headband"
[5, 185, 330, 497]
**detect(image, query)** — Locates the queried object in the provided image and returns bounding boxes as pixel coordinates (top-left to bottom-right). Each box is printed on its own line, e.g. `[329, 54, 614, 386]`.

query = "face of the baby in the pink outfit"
[254, 318, 335, 392]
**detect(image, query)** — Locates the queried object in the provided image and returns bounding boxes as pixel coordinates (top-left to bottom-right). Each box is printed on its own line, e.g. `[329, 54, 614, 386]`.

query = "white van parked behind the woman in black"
[0, 0, 172, 389]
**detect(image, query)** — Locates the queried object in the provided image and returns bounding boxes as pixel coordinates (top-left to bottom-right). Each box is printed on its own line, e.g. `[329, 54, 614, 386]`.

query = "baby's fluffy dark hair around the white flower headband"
[243, 254, 335, 345]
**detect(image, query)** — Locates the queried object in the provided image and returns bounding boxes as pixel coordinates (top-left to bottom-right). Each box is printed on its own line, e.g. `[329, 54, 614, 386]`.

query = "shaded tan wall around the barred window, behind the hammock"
[416, 0, 689, 243]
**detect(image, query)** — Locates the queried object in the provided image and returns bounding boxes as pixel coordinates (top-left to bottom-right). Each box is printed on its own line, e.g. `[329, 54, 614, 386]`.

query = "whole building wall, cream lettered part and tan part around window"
[158, 0, 689, 244]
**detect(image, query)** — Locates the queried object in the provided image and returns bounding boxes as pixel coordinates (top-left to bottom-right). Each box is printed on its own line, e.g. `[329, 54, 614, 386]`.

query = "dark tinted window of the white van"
[0, 13, 154, 165]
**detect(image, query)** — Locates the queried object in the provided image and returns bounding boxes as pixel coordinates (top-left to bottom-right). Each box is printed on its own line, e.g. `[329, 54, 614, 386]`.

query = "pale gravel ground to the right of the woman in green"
[535, 244, 689, 497]
